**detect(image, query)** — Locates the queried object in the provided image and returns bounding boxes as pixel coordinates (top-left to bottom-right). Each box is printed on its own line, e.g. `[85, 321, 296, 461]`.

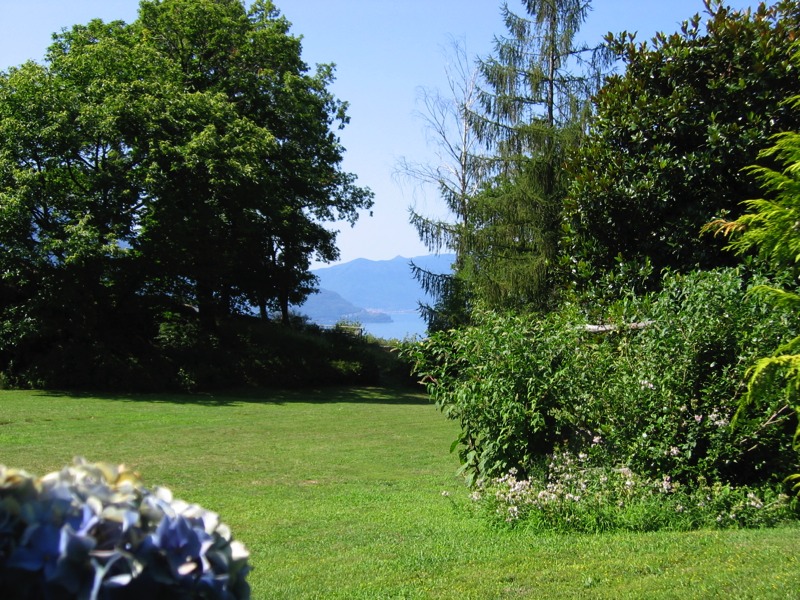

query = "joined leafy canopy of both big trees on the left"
[0, 0, 372, 385]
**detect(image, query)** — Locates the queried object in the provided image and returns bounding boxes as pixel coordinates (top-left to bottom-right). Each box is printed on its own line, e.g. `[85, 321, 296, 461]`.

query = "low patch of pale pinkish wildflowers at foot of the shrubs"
[471, 451, 798, 533]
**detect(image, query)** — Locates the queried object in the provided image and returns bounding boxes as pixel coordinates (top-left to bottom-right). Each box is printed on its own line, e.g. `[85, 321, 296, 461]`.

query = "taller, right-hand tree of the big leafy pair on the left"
[139, 0, 371, 318]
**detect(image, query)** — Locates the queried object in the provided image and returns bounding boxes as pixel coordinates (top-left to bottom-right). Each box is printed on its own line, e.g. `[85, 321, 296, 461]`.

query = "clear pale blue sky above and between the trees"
[0, 0, 756, 261]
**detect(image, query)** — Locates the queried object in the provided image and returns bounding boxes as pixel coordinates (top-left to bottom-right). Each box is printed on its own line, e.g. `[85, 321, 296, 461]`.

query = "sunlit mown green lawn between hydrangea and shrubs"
[0, 388, 800, 599]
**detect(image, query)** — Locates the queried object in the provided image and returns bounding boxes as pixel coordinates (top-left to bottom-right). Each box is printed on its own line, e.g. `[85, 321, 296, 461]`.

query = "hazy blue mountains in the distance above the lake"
[296, 254, 455, 323]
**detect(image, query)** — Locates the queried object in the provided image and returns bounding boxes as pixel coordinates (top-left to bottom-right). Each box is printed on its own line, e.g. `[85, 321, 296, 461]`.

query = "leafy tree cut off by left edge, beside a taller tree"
[0, 21, 164, 380]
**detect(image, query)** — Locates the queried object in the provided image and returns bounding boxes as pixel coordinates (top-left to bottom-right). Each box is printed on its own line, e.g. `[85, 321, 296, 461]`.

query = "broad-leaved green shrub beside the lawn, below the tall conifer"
[402, 304, 581, 481]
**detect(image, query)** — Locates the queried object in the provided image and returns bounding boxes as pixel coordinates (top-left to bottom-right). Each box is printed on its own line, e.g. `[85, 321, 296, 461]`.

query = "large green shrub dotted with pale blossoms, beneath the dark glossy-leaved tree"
[580, 270, 797, 483]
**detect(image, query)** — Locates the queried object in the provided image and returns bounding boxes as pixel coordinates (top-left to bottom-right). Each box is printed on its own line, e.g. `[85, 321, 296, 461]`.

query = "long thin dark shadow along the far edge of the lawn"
[35, 387, 431, 406]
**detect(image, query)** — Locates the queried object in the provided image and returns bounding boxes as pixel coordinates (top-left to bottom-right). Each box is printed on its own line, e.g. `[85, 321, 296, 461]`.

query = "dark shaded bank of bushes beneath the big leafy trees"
[0, 312, 400, 392]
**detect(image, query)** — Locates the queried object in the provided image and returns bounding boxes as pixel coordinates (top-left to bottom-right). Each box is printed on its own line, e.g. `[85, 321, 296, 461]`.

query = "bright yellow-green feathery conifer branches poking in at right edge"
[706, 67, 800, 489]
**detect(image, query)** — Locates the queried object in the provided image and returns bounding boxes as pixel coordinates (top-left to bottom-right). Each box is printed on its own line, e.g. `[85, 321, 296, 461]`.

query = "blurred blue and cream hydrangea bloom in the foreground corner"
[0, 459, 250, 600]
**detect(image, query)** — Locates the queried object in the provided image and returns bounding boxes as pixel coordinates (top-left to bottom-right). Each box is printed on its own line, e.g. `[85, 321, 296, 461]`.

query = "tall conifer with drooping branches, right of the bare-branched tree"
[463, 0, 600, 307]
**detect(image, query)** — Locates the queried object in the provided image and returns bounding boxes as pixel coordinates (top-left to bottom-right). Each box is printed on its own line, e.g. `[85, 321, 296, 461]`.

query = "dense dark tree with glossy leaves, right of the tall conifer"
[563, 0, 800, 287]
